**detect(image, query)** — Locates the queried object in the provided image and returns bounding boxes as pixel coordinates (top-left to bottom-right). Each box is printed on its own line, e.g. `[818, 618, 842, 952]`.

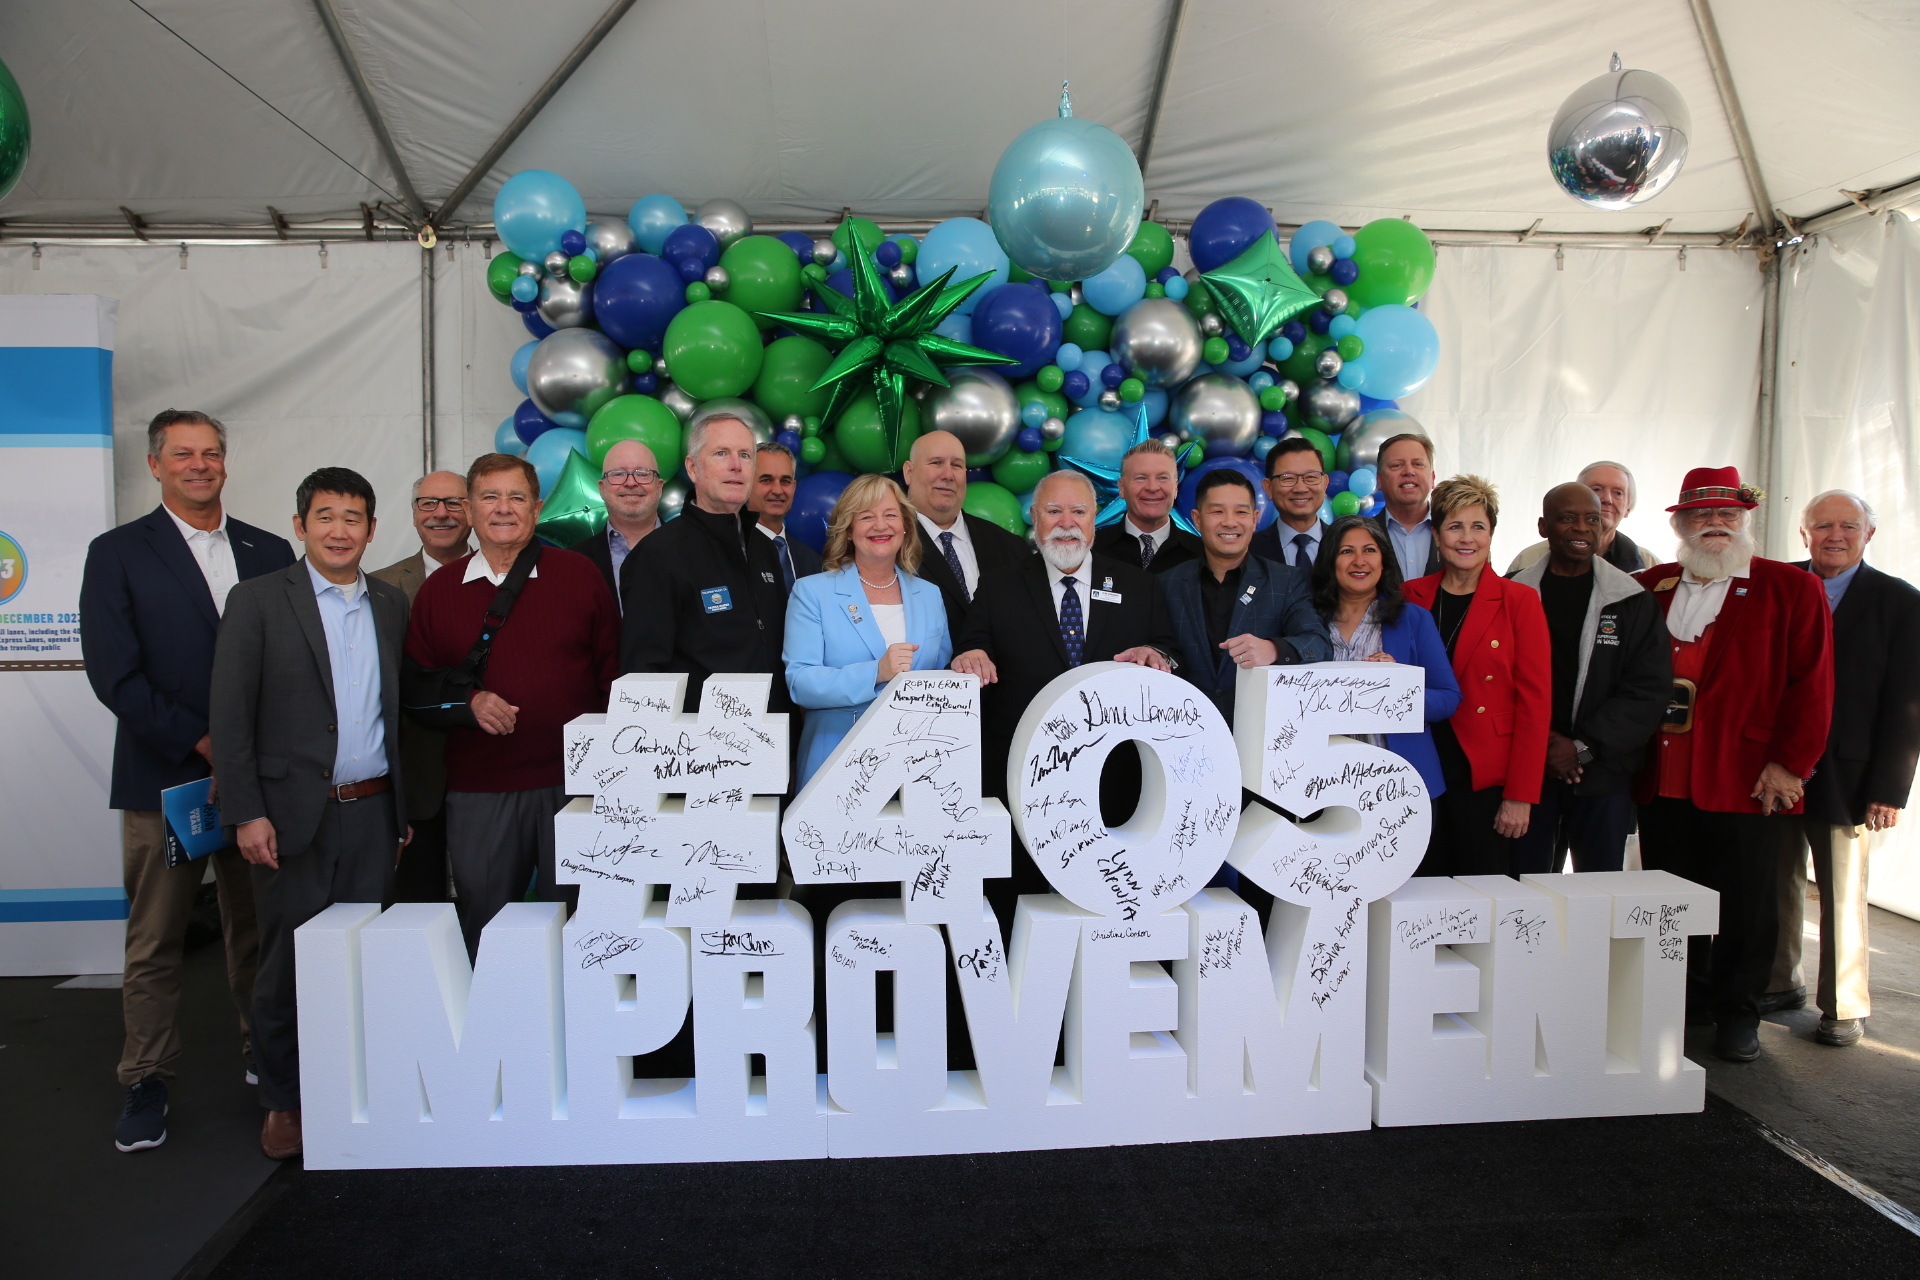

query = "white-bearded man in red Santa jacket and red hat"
[1634, 466, 1834, 1061]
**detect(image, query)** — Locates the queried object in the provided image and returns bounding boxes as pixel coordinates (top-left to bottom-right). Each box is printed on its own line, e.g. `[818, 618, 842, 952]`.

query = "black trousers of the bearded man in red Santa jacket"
[1640, 796, 1799, 1027]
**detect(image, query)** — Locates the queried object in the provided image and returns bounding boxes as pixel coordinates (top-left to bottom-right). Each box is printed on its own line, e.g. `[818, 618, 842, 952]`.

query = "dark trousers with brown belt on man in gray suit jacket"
[252, 791, 399, 1111]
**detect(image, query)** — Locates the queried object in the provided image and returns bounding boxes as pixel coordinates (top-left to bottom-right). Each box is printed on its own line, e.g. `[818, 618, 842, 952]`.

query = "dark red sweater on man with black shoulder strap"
[407, 547, 620, 791]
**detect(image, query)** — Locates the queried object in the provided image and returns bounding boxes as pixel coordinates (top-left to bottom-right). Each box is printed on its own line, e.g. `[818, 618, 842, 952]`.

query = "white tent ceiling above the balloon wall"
[0, 0, 1920, 238]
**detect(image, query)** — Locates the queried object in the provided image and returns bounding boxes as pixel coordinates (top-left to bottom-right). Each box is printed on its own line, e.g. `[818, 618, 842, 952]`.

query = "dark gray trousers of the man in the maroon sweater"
[445, 787, 580, 958]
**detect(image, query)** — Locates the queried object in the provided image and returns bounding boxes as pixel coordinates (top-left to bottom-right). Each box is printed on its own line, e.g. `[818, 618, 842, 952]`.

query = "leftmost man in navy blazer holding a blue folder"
[81, 409, 294, 1151]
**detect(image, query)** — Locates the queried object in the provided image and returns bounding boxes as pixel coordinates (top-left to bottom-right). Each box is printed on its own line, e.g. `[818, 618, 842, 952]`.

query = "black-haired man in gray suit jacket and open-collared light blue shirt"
[209, 466, 407, 1159]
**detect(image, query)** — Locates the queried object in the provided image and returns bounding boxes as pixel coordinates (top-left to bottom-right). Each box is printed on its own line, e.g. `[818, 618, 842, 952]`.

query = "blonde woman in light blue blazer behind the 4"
[783, 476, 952, 787]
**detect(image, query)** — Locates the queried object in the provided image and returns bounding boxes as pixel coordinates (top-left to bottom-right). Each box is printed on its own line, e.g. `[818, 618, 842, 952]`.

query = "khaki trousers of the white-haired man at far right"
[1766, 818, 1872, 1021]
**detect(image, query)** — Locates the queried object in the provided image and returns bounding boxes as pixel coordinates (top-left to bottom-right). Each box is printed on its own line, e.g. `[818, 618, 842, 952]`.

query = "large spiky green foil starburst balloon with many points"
[755, 218, 1020, 457]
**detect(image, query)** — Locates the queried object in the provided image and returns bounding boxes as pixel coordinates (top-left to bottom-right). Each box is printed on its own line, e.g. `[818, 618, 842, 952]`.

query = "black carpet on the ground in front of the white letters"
[213, 1100, 1920, 1280]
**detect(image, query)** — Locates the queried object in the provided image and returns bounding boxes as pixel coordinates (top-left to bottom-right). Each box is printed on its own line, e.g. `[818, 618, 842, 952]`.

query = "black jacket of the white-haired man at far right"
[1799, 560, 1920, 827]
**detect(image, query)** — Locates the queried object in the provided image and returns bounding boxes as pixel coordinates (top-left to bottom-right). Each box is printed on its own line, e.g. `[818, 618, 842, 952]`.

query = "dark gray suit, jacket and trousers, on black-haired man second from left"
[209, 560, 407, 1111]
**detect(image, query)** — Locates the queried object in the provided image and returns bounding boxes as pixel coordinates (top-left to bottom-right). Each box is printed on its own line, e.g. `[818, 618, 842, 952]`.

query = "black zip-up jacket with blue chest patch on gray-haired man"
[620, 503, 793, 712]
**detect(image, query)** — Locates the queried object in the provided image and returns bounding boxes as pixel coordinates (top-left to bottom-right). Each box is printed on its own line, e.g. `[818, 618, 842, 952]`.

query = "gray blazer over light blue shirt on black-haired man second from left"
[209, 560, 407, 856]
